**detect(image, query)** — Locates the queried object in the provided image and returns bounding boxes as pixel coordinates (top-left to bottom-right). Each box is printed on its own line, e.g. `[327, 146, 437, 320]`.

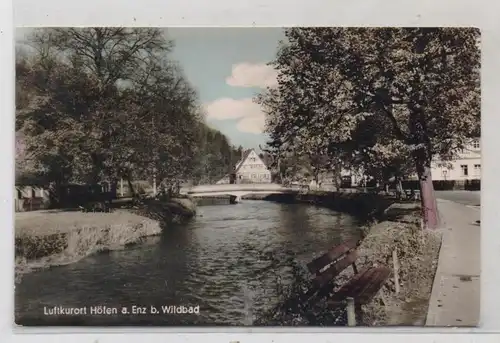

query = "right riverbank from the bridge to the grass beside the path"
[240, 191, 441, 326]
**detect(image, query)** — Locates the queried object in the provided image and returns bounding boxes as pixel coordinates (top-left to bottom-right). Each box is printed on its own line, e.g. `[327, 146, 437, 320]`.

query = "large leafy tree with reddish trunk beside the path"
[257, 28, 480, 227]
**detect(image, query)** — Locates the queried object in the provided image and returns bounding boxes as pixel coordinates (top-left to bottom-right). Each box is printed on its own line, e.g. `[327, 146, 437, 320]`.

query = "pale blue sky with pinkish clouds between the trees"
[16, 28, 284, 153]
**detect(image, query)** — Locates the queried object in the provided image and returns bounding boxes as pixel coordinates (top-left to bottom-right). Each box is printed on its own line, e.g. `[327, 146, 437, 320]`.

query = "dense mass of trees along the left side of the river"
[16, 28, 239, 195]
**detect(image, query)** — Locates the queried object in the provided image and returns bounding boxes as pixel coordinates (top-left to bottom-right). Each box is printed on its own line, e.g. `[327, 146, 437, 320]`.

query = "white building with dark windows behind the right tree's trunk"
[432, 139, 481, 181]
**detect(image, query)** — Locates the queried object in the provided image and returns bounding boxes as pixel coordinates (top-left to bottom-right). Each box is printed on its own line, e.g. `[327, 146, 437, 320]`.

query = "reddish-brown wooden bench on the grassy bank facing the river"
[303, 239, 391, 326]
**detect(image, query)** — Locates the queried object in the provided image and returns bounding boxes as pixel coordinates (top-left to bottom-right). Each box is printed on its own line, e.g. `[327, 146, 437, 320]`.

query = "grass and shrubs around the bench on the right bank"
[255, 203, 441, 326]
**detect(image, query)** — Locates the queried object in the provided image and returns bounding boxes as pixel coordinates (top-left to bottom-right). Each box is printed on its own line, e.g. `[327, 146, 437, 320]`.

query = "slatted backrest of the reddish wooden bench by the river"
[307, 239, 361, 288]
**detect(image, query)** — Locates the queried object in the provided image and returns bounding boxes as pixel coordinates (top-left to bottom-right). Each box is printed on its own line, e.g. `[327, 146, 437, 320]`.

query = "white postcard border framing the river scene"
[0, 0, 500, 343]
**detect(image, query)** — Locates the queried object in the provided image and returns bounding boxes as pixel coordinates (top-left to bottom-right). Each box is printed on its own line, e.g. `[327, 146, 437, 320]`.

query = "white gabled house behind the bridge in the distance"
[217, 149, 271, 184]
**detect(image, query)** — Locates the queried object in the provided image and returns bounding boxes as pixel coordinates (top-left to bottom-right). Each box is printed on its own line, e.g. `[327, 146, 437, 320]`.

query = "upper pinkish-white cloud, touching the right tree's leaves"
[226, 63, 278, 88]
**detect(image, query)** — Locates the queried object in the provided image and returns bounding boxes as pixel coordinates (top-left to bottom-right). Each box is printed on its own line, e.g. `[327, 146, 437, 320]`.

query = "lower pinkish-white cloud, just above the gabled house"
[205, 98, 266, 134]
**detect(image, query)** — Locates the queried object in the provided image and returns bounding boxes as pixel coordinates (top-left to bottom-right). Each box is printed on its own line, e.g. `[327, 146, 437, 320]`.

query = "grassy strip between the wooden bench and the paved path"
[358, 204, 441, 326]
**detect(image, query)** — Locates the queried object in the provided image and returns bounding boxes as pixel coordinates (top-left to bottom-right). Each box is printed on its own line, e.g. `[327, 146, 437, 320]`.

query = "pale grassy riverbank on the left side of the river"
[15, 199, 196, 282]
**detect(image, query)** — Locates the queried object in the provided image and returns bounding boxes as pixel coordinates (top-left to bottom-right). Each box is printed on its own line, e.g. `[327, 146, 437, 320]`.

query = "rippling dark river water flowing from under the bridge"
[15, 200, 360, 326]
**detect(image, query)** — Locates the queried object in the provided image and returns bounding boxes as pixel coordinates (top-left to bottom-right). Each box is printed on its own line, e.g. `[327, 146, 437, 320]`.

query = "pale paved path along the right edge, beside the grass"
[426, 198, 480, 327]
